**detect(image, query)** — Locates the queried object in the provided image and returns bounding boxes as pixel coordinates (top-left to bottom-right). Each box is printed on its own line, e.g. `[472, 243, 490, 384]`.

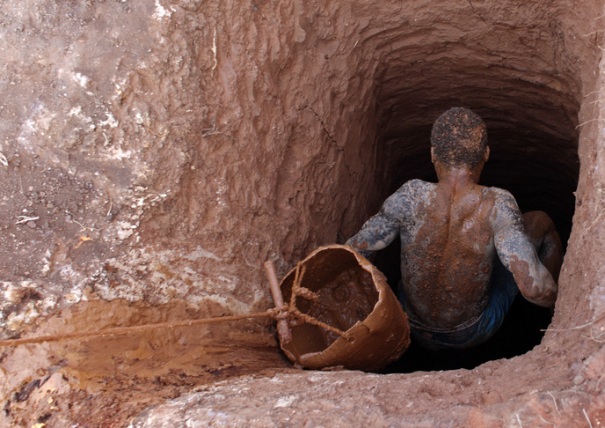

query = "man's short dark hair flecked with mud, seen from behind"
[431, 107, 487, 167]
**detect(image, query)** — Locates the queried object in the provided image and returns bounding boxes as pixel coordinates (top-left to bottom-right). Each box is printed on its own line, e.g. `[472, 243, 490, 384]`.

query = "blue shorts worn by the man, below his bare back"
[399, 256, 519, 350]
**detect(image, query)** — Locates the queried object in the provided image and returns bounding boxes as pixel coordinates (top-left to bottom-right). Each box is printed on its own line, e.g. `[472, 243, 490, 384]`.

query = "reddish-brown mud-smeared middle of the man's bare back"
[402, 183, 494, 328]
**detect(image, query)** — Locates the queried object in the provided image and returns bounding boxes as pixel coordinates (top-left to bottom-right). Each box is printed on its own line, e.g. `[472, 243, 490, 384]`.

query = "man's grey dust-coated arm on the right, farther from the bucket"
[493, 189, 557, 307]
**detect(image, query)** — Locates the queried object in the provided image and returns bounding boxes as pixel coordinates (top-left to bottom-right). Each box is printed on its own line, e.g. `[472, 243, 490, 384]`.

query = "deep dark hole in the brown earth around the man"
[340, 16, 582, 372]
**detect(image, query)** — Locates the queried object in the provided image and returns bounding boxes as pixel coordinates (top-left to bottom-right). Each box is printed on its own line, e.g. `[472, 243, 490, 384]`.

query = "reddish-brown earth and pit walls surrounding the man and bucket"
[0, 0, 605, 427]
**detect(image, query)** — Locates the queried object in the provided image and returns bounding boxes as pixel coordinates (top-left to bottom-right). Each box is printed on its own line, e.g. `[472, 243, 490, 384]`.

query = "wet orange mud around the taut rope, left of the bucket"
[0, 301, 291, 427]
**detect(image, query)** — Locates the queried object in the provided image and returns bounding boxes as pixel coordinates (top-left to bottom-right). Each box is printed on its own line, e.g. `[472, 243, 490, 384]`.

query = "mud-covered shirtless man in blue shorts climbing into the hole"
[347, 108, 562, 350]
